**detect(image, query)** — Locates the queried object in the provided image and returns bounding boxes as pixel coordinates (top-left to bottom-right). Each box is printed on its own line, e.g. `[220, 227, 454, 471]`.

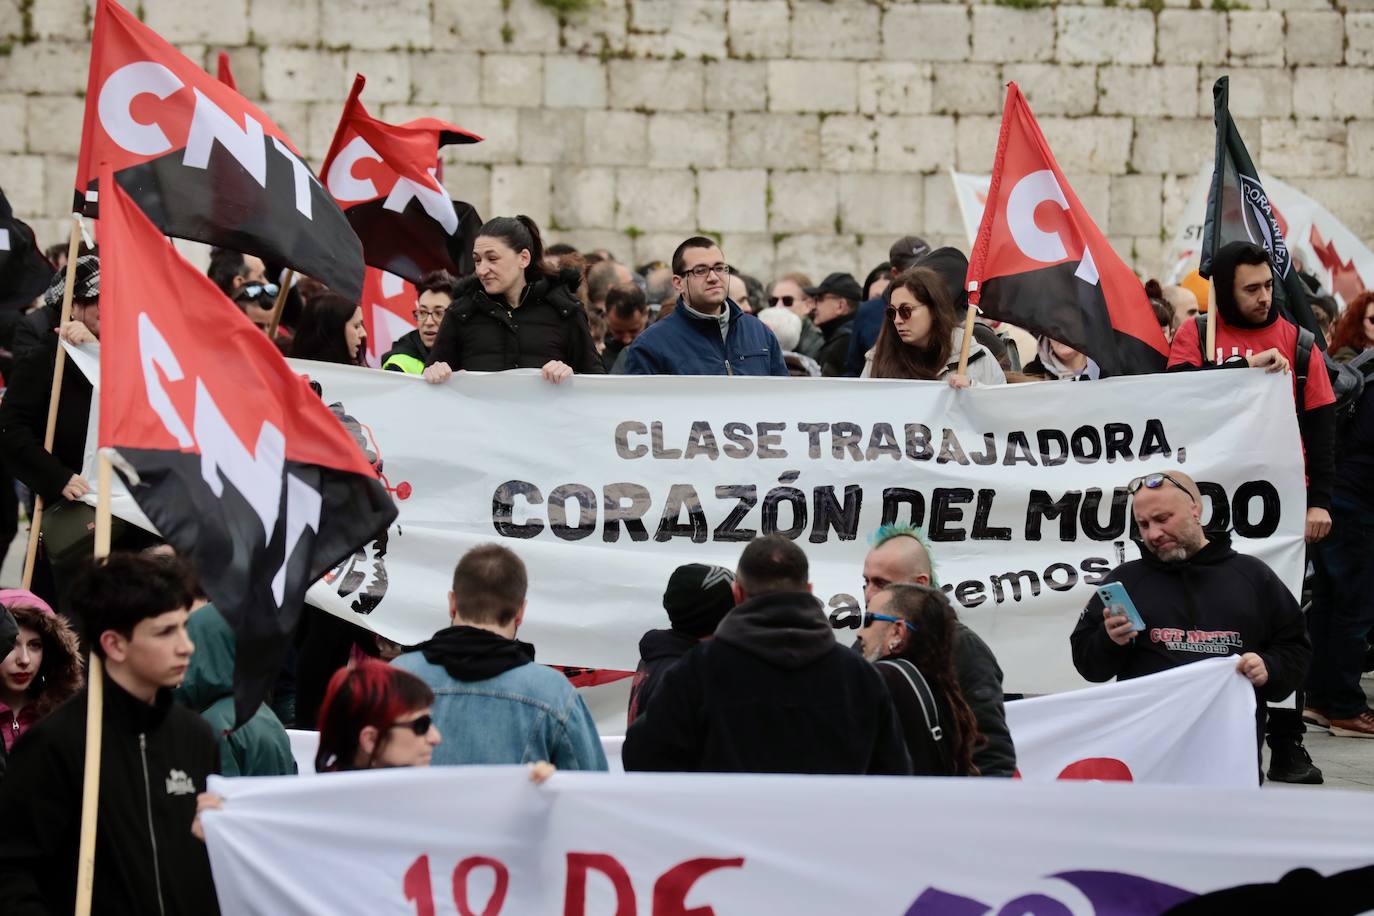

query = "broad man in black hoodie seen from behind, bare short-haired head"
[622, 534, 911, 776]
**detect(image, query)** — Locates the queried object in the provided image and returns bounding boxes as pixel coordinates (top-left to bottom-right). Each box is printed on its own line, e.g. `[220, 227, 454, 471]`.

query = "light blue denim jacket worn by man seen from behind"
[392, 652, 606, 770]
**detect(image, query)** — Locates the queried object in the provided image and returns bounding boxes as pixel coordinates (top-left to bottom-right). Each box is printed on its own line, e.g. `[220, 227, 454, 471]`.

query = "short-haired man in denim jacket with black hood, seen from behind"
[392, 544, 606, 770]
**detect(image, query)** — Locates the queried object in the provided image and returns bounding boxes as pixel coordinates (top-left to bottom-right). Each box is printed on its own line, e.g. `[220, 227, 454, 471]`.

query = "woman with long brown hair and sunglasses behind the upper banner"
[860, 268, 1007, 389]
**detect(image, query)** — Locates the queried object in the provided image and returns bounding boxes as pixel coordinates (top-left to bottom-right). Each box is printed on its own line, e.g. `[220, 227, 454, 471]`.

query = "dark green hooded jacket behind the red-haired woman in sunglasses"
[176, 604, 295, 776]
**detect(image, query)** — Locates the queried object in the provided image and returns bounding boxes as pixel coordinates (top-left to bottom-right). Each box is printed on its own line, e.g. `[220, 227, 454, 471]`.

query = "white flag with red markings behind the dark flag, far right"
[1164, 166, 1374, 304]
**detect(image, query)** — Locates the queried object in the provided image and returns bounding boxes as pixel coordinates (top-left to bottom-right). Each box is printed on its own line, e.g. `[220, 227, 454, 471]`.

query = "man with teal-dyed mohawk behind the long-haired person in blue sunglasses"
[857, 525, 1017, 777]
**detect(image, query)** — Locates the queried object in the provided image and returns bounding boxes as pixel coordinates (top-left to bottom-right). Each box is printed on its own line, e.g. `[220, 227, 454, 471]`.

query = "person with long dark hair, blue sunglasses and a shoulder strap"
[855, 585, 982, 776]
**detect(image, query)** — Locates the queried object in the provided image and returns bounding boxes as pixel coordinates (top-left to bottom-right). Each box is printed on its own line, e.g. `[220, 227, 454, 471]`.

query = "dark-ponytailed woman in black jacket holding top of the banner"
[425, 216, 605, 385]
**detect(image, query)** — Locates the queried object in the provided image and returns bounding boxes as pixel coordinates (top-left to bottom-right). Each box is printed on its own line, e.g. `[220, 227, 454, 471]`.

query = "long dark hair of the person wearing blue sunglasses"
[883, 585, 987, 776]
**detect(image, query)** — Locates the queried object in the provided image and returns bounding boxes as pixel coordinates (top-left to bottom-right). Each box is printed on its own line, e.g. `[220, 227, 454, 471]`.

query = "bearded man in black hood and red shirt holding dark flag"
[1169, 242, 1336, 544]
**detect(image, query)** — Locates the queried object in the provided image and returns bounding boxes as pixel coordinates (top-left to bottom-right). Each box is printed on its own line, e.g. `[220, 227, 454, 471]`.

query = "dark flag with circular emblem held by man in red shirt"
[1198, 77, 1326, 350]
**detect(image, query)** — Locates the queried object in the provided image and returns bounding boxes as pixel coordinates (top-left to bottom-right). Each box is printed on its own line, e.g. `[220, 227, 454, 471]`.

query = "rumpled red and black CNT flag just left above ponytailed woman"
[320, 74, 482, 283]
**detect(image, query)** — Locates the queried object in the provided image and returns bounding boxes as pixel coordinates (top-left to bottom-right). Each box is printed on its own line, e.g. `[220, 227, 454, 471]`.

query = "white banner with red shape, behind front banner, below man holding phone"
[290, 658, 1259, 788]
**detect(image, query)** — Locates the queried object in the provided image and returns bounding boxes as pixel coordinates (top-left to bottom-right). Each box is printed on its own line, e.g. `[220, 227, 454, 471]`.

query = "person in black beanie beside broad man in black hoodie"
[629, 563, 735, 722]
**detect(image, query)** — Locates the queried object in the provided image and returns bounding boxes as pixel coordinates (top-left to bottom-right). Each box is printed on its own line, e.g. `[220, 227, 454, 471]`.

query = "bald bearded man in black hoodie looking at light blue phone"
[1069, 470, 1320, 783]
